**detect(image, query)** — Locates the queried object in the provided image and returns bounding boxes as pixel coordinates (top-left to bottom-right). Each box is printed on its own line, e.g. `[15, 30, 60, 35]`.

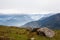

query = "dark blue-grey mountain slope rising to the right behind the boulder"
[24, 13, 60, 29]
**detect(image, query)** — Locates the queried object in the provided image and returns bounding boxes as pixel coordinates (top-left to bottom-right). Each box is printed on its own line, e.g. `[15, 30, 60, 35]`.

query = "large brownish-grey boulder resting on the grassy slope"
[37, 27, 55, 38]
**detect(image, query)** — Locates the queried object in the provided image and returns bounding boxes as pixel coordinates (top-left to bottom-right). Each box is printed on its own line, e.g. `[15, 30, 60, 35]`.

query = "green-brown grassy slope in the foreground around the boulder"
[0, 26, 60, 40]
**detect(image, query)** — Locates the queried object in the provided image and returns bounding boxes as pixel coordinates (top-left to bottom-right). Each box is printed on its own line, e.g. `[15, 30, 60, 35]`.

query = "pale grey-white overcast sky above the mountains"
[0, 0, 60, 14]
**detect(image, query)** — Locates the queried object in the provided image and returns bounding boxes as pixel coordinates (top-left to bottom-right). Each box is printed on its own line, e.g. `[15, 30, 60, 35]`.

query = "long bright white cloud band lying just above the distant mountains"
[0, 9, 53, 14]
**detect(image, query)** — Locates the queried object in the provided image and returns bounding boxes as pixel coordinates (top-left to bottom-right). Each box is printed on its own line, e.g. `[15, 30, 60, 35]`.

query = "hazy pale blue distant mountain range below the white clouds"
[0, 14, 51, 27]
